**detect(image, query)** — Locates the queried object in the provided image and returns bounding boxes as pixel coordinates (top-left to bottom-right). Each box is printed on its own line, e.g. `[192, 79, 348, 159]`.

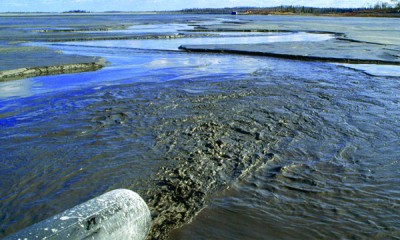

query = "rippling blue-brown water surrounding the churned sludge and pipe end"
[0, 14, 400, 239]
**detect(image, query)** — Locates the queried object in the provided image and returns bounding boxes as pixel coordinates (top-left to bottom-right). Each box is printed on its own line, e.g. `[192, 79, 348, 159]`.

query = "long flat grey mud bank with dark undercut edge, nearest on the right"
[180, 39, 400, 65]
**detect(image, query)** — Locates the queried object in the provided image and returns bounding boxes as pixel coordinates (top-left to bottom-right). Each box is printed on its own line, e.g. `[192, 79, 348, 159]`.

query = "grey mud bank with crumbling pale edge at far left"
[0, 46, 106, 81]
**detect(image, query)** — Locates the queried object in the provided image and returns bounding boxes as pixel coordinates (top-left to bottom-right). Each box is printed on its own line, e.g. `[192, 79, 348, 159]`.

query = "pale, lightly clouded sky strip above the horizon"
[0, 0, 388, 12]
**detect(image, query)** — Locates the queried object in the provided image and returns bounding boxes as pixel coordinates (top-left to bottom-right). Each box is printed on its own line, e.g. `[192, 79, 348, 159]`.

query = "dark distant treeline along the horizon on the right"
[179, 3, 400, 14]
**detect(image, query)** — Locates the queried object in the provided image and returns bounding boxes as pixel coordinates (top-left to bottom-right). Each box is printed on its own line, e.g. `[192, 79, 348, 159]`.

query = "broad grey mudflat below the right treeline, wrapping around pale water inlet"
[181, 16, 400, 65]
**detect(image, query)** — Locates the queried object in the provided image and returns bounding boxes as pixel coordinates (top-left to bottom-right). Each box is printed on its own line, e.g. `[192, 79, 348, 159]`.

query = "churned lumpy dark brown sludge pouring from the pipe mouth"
[148, 119, 272, 239]
